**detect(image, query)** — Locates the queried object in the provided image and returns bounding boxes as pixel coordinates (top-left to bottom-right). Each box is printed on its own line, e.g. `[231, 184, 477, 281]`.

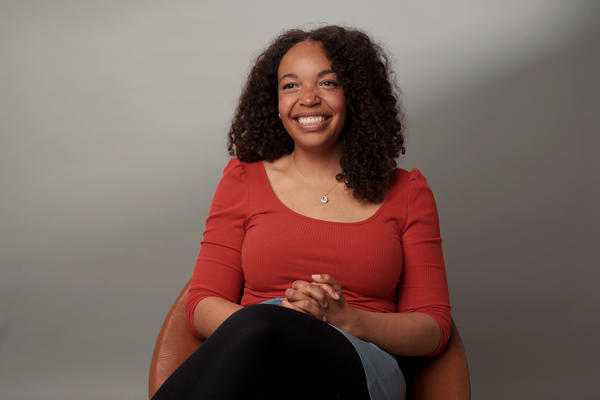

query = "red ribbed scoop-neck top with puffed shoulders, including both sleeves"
[186, 159, 452, 355]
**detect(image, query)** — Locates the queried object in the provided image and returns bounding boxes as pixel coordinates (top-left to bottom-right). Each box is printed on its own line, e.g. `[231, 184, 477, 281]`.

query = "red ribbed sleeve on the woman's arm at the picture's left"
[185, 158, 248, 336]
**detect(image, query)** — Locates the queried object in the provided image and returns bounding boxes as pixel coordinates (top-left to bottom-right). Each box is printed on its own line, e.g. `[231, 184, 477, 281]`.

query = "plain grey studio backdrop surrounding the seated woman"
[0, 0, 600, 399]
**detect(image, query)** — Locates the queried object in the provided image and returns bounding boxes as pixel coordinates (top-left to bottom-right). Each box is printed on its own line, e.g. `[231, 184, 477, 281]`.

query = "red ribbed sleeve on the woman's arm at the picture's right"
[398, 168, 452, 355]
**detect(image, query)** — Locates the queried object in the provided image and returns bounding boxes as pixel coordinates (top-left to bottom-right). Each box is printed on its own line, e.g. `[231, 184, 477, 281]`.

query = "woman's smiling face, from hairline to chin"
[277, 41, 346, 151]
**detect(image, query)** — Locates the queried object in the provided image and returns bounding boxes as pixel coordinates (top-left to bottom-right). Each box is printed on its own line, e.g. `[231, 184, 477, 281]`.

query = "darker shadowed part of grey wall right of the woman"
[409, 30, 600, 399]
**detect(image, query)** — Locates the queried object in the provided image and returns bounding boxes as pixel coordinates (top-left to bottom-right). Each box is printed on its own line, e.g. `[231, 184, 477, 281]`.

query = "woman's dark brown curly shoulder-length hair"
[227, 26, 405, 203]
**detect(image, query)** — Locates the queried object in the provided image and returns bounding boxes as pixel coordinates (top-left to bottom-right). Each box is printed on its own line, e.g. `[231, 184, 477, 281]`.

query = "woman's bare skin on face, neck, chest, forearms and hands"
[194, 41, 440, 356]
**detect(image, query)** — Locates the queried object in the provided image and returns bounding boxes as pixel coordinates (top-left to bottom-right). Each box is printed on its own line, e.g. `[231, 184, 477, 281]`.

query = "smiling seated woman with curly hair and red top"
[155, 26, 451, 399]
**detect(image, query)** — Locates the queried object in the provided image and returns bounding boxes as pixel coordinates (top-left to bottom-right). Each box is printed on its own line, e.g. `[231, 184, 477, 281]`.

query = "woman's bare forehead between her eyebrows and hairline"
[277, 40, 331, 76]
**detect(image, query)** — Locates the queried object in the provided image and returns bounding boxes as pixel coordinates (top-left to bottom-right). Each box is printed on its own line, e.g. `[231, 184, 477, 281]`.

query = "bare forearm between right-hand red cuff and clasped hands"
[340, 307, 441, 356]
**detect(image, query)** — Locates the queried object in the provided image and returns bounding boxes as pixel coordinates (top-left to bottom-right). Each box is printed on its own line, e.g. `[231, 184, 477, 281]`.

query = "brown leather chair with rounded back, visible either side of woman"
[148, 282, 471, 400]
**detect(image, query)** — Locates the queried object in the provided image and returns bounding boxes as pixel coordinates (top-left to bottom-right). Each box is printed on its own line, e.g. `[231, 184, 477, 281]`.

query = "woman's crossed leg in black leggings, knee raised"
[153, 304, 369, 400]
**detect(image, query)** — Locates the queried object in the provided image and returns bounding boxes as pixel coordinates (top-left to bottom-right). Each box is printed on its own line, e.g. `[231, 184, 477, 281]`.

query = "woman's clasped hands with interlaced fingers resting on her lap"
[281, 274, 355, 331]
